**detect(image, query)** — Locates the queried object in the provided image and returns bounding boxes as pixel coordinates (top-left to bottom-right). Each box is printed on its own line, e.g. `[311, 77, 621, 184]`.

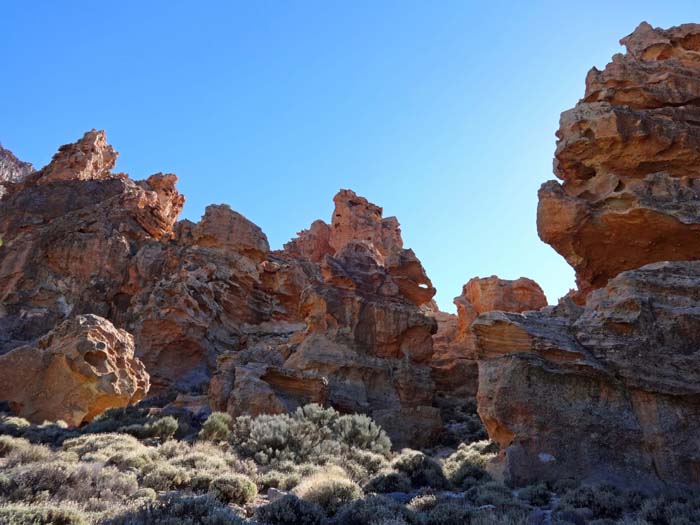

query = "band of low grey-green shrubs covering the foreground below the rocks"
[0, 405, 700, 525]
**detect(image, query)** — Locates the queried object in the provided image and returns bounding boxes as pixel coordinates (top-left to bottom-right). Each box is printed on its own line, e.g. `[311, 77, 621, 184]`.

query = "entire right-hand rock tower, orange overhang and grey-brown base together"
[472, 23, 700, 484]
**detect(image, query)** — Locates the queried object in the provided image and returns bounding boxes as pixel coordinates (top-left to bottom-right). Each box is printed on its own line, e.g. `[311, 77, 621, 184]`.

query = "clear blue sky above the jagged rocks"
[0, 0, 700, 310]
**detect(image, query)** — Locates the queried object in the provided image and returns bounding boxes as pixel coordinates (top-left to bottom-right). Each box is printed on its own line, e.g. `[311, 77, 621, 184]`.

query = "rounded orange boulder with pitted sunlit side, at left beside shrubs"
[0, 315, 149, 425]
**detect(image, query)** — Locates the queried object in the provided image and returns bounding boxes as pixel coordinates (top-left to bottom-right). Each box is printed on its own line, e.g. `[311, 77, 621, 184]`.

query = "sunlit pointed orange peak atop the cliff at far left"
[37, 129, 118, 184]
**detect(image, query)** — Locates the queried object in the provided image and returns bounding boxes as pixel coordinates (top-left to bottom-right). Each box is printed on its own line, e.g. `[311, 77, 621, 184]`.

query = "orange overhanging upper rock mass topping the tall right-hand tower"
[537, 23, 700, 304]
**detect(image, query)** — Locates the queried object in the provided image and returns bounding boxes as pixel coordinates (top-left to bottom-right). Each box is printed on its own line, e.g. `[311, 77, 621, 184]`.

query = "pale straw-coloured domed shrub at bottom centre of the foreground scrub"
[294, 471, 362, 516]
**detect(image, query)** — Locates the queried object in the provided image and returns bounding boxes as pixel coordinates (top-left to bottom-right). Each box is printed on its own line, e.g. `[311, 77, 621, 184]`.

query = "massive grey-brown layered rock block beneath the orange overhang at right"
[472, 261, 700, 486]
